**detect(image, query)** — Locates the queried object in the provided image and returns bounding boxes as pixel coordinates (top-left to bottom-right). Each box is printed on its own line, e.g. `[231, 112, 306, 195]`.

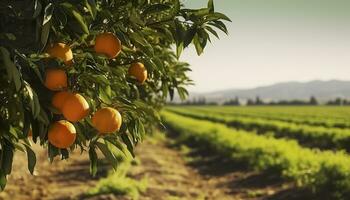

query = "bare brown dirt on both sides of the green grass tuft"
[0, 136, 304, 200]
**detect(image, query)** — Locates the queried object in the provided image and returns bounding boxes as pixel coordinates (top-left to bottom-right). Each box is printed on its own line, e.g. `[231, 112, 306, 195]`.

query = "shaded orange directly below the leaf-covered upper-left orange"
[45, 69, 68, 91]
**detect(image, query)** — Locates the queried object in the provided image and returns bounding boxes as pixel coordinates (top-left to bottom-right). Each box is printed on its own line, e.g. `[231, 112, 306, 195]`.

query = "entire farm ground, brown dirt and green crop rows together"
[0, 106, 350, 200]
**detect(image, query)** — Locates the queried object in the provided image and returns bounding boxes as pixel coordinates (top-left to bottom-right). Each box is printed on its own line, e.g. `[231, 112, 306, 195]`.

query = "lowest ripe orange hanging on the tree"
[48, 120, 76, 149]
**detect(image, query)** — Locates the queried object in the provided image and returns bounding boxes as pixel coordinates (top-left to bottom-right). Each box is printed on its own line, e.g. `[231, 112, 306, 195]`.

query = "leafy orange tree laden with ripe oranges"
[0, 0, 229, 189]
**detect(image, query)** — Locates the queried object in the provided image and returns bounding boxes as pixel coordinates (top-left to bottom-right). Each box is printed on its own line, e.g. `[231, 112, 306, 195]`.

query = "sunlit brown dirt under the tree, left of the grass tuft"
[0, 143, 104, 200]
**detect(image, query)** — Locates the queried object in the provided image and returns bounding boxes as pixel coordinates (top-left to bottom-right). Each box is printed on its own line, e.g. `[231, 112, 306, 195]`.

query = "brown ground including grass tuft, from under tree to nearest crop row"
[0, 133, 288, 200]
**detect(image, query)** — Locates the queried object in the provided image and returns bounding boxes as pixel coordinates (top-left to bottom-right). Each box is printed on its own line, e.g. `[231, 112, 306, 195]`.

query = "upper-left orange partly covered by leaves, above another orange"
[47, 43, 73, 65]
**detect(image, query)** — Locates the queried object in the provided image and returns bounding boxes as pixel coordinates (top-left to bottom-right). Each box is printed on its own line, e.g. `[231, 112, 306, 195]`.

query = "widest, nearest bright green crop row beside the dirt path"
[162, 111, 350, 199]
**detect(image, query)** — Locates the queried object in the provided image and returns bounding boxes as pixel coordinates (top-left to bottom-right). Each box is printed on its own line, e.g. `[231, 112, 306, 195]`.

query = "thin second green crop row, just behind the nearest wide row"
[167, 107, 350, 151]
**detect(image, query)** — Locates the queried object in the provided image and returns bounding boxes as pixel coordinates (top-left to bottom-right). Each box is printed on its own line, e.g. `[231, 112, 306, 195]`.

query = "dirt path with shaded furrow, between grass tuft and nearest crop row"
[130, 140, 300, 200]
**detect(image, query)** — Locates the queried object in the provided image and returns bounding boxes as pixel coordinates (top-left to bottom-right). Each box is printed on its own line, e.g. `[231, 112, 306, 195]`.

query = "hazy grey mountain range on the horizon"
[189, 80, 350, 102]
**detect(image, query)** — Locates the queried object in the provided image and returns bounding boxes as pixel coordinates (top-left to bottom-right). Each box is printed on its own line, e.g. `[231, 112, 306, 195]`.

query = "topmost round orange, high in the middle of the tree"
[94, 32, 122, 59]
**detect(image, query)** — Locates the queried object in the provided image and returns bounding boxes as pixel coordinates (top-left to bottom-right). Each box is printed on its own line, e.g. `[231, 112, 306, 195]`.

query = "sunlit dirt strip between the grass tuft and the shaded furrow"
[130, 142, 232, 200]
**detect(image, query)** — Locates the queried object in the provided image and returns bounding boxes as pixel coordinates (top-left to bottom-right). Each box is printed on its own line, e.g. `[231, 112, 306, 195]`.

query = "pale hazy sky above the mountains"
[181, 0, 350, 92]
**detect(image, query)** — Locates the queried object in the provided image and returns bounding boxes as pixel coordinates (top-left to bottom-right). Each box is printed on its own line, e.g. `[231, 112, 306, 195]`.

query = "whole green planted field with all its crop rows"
[163, 107, 350, 199]
